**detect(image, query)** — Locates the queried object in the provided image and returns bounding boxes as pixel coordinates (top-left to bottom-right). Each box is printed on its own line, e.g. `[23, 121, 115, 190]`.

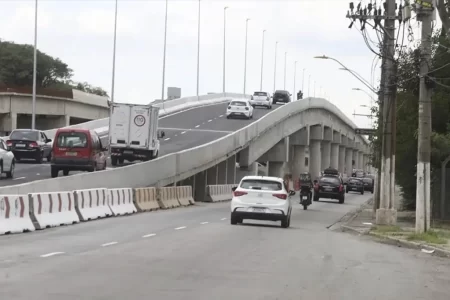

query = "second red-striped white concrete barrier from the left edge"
[28, 192, 80, 229]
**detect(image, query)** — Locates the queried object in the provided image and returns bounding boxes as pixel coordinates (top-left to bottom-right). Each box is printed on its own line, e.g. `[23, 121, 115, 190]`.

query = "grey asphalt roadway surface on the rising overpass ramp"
[0, 103, 279, 186]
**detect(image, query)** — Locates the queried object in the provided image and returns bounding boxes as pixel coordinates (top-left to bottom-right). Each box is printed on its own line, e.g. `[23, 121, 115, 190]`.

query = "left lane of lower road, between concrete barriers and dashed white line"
[0, 203, 230, 264]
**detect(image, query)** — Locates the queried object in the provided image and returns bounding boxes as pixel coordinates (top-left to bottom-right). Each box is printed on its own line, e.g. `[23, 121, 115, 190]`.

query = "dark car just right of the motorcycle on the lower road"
[314, 174, 345, 204]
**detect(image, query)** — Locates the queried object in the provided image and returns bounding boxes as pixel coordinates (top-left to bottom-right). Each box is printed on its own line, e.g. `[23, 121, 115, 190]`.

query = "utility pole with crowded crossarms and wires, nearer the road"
[347, 0, 410, 225]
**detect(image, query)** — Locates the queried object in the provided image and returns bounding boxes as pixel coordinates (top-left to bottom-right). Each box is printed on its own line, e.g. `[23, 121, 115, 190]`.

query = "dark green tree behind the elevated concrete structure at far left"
[0, 40, 107, 96]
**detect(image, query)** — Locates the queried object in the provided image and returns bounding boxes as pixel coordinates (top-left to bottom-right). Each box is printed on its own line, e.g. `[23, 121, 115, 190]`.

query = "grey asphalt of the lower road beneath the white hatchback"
[0, 194, 450, 300]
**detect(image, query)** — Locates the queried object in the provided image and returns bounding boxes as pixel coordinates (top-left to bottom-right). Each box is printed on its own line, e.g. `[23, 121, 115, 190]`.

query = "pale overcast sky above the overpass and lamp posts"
[0, 0, 426, 127]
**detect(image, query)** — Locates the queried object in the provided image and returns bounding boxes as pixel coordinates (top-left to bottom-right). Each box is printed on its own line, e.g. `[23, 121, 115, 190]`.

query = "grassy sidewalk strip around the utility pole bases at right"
[341, 203, 450, 258]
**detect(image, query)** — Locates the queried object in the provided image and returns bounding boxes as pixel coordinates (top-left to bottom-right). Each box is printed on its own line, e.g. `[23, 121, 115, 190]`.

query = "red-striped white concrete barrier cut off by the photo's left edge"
[0, 195, 35, 234]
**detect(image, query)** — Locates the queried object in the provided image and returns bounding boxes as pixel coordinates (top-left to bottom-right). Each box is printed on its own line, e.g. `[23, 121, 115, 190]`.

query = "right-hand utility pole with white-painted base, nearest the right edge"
[414, 0, 434, 233]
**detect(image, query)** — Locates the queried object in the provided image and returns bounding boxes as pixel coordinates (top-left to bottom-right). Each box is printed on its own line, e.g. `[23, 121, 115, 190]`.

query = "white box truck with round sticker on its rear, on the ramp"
[109, 102, 165, 166]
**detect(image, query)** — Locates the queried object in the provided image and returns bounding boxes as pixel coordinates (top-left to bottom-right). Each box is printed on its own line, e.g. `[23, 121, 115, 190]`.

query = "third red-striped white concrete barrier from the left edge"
[74, 188, 113, 221]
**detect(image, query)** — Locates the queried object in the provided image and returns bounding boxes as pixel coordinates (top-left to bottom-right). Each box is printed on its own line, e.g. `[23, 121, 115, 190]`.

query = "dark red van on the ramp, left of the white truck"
[51, 128, 107, 178]
